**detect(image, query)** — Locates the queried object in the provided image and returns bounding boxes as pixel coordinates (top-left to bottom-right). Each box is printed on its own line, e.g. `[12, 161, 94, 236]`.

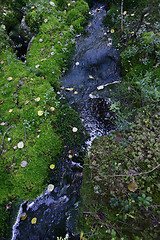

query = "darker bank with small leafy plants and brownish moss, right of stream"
[79, 1, 160, 240]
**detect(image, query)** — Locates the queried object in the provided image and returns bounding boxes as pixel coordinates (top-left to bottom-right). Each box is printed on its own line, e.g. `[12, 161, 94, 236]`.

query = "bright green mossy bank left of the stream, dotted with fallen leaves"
[0, 0, 88, 239]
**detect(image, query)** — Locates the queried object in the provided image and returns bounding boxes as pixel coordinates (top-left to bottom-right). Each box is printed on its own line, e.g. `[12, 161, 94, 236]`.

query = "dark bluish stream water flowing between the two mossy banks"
[12, 3, 120, 240]
